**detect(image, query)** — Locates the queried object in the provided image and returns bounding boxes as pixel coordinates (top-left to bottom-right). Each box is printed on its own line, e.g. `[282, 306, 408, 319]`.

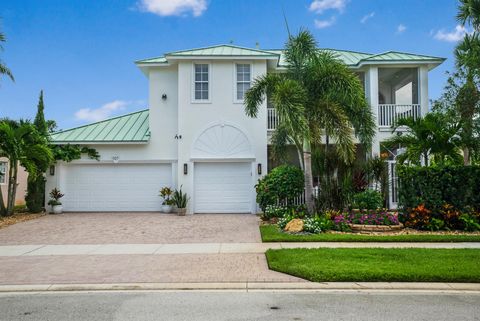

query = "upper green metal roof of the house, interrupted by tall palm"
[136, 45, 445, 67]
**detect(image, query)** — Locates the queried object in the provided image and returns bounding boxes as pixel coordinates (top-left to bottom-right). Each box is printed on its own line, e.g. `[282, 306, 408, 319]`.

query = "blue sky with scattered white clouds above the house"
[0, 0, 468, 129]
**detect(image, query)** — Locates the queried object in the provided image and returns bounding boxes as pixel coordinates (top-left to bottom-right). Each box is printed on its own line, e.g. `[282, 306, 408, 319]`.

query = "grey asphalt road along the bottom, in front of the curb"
[0, 292, 480, 321]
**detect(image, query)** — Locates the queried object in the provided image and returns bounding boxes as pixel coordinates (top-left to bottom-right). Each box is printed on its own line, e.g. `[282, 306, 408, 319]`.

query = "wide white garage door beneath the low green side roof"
[62, 164, 172, 212]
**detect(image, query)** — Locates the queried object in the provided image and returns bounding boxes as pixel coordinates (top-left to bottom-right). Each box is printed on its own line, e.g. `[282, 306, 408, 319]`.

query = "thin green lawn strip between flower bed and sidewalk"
[260, 225, 480, 242]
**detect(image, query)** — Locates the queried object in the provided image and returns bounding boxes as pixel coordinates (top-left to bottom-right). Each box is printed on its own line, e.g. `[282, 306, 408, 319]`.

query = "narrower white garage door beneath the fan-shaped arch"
[194, 163, 253, 213]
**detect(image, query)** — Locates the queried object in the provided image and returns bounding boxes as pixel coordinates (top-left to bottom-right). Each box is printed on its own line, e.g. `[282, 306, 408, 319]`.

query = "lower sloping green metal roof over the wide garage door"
[50, 109, 150, 144]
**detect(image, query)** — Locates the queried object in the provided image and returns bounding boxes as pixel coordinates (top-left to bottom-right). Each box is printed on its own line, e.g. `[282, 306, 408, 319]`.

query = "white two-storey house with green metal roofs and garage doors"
[47, 45, 444, 213]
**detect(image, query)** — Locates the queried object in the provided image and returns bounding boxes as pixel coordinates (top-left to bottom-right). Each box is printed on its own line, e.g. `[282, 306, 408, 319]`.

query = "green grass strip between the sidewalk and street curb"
[266, 248, 480, 283]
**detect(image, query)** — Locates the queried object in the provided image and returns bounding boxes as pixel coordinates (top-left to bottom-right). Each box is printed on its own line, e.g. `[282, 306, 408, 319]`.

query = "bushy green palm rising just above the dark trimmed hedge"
[384, 112, 462, 166]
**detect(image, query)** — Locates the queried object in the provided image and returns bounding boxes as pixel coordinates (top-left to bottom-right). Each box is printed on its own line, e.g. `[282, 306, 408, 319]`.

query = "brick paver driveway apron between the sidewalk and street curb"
[0, 254, 306, 285]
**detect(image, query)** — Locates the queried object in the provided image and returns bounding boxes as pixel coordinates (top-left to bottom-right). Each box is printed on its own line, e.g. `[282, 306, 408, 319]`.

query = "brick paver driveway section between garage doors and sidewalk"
[0, 213, 261, 245]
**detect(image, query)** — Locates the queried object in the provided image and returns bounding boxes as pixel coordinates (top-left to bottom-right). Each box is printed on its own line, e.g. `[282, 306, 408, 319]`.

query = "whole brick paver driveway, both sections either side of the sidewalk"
[0, 213, 301, 285]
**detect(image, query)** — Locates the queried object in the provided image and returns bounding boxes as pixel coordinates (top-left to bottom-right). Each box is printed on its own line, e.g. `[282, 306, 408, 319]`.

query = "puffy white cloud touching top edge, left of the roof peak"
[138, 0, 207, 17]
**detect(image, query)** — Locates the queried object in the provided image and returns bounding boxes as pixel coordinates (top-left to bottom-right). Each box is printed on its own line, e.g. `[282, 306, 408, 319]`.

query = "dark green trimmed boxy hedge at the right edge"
[397, 166, 480, 213]
